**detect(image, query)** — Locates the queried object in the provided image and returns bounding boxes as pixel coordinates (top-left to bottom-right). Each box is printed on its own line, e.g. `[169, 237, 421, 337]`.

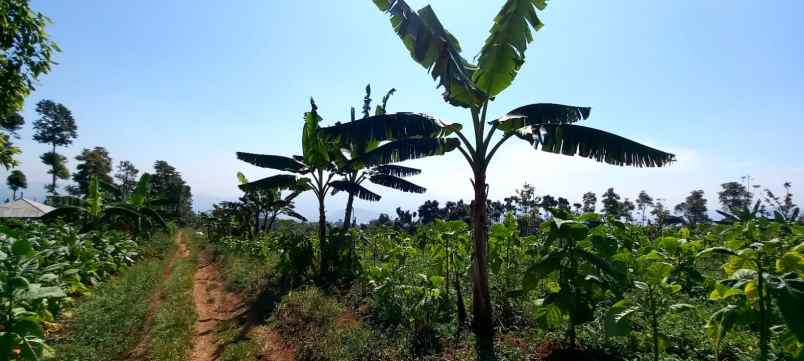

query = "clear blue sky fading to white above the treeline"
[0, 0, 804, 219]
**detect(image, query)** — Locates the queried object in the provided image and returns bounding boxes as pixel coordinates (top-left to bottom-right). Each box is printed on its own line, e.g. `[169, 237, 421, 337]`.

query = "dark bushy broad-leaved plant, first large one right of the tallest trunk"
[523, 210, 623, 347]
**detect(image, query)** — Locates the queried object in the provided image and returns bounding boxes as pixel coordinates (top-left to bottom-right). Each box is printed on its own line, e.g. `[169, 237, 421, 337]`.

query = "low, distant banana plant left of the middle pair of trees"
[237, 172, 307, 233]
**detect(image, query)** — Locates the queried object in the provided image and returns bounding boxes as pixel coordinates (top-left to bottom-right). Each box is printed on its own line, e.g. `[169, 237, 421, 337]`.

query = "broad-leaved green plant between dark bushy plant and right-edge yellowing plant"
[604, 237, 694, 361]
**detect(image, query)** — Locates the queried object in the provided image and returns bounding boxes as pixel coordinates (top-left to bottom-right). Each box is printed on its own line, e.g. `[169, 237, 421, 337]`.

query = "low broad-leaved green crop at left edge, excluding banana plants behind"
[0, 223, 140, 360]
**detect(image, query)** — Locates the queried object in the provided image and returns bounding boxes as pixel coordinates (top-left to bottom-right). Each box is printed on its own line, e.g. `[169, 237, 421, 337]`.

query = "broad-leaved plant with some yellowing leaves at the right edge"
[699, 218, 804, 361]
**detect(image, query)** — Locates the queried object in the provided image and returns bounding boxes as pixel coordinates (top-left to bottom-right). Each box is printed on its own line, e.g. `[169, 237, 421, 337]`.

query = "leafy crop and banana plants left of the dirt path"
[0, 165, 191, 360]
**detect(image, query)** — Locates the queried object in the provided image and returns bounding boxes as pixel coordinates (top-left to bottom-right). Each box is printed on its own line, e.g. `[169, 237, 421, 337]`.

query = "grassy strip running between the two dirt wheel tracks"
[148, 231, 198, 361]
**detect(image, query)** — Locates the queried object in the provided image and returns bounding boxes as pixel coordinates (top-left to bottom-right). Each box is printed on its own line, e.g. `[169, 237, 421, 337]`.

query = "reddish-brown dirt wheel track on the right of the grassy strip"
[187, 253, 244, 361]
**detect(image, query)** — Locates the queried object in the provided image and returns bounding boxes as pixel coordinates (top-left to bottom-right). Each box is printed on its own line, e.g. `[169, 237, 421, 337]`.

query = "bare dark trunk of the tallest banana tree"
[472, 169, 496, 361]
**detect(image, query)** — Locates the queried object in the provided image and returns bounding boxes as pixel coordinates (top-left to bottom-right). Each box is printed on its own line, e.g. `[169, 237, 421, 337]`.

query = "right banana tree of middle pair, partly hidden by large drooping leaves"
[332, 85, 426, 230]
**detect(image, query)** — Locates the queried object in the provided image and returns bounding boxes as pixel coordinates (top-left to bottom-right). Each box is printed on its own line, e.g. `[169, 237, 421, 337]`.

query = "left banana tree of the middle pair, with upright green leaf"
[237, 99, 338, 275]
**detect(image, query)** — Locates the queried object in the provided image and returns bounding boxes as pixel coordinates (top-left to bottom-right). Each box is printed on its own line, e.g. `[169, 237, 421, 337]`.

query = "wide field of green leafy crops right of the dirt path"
[199, 180, 804, 360]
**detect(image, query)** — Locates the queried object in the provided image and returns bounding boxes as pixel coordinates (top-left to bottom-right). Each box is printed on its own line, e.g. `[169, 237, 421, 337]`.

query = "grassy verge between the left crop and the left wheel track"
[52, 235, 175, 361]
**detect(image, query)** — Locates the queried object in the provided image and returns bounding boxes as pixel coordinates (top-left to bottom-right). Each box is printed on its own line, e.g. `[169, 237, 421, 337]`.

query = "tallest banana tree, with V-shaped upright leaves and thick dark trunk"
[358, 0, 674, 360]
